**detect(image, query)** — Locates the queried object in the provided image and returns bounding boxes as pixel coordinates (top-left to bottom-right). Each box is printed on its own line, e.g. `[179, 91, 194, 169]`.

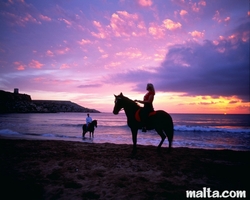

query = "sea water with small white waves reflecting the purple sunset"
[0, 112, 250, 151]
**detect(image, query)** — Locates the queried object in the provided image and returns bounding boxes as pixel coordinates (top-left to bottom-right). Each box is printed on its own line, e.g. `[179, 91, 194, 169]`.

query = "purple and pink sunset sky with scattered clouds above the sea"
[0, 0, 250, 114]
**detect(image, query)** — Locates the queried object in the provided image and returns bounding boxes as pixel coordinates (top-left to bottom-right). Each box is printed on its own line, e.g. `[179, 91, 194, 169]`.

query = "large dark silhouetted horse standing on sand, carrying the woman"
[113, 93, 174, 154]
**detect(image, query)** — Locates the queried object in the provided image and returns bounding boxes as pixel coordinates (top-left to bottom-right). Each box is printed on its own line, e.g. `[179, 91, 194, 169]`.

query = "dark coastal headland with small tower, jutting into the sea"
[0, 90, 100, 113]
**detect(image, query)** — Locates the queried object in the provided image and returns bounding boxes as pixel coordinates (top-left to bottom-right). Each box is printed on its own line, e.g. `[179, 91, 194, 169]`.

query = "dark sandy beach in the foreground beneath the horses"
[0, 139, 250, 200]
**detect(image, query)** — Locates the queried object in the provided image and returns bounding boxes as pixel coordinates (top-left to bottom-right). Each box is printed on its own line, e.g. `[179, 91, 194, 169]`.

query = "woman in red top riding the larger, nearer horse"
[135, 83, 155, 132]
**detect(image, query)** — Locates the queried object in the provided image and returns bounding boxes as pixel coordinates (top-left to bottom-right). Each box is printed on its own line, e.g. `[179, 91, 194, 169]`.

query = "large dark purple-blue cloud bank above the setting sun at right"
[108, 20, 249, 102]
